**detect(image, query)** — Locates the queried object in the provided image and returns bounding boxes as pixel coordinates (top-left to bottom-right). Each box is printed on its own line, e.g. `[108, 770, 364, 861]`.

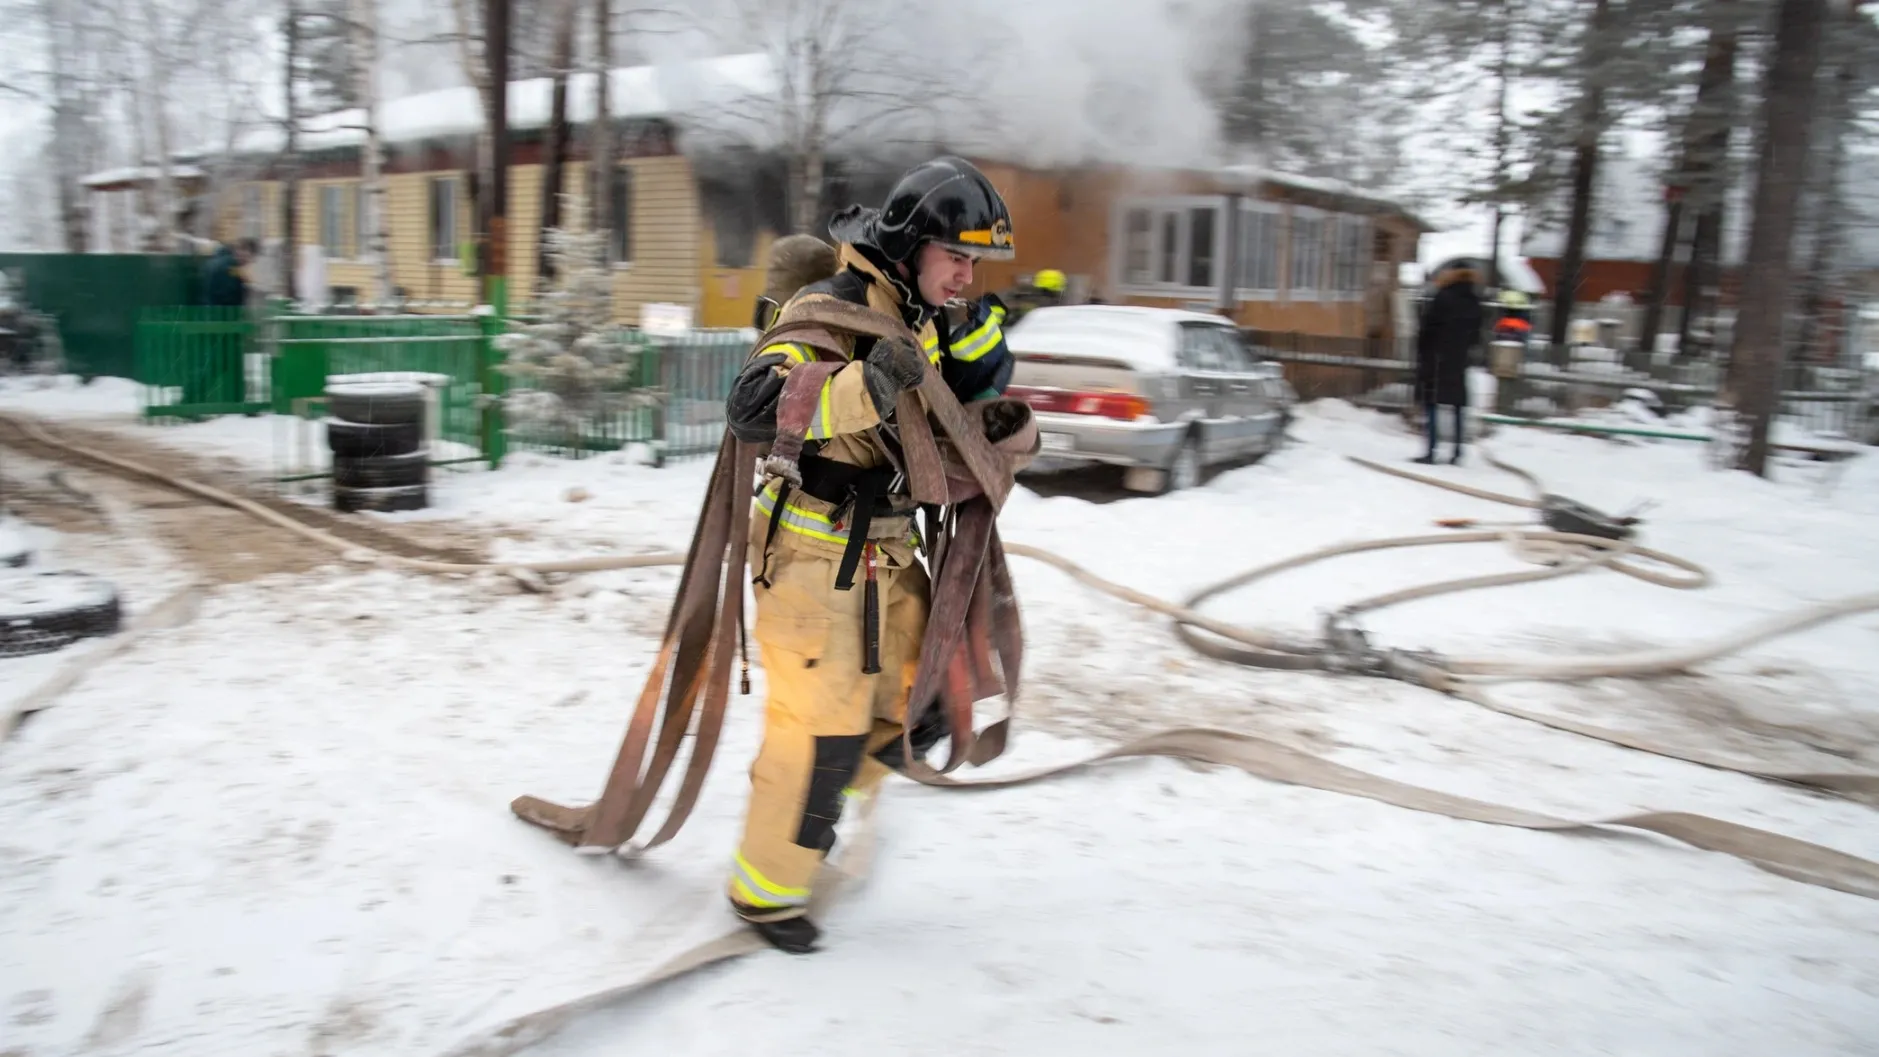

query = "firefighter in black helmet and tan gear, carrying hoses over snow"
[727, 158, 1013, 954]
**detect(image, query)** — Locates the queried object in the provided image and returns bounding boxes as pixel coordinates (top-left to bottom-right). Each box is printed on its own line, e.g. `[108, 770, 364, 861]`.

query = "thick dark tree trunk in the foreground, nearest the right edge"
[1725, 0, 1828, 477]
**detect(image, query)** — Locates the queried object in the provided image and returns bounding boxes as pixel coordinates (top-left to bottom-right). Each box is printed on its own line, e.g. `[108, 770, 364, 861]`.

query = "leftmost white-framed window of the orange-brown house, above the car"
[1110, 195, 1225, 295]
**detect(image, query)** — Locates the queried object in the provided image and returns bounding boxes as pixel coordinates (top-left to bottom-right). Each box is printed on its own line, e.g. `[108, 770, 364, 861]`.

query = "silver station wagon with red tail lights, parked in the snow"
[1005, 304, 1297, 492]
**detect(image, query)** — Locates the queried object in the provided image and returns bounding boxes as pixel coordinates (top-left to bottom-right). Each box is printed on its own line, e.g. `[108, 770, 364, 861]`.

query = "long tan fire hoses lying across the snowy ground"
[0, 415, 1879, 1057]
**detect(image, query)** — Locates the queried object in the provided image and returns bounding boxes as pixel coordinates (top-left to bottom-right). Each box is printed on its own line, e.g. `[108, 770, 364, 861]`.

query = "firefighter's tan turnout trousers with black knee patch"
[729, 483, 928, 922]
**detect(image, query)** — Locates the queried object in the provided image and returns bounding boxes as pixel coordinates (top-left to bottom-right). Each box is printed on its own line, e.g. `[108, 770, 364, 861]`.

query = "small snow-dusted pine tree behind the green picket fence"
[496, 227, 663, 451]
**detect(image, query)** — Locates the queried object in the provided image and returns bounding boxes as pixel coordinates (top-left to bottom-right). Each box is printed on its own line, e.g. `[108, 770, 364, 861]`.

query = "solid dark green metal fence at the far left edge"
[0, 253, 201, 381]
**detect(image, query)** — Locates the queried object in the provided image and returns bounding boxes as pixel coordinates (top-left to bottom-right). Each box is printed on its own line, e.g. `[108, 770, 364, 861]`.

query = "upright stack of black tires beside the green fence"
[327, 381, 430, 513]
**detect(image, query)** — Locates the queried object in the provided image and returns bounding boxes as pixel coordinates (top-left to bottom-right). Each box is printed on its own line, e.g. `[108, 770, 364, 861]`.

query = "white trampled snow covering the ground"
[0, 386, 1879, 1057]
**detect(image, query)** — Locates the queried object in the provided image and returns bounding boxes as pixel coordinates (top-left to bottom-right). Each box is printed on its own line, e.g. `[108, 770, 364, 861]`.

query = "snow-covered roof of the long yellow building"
[235, 53, 776, 154]
